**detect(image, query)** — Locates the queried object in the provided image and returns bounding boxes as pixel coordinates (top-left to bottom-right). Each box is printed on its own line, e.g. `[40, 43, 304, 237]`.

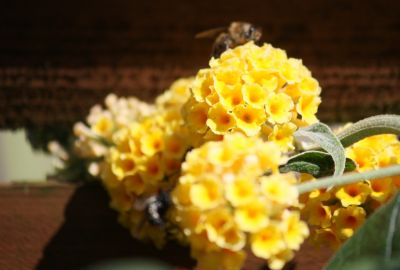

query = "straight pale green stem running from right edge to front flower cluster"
[297, 165, 400, 194]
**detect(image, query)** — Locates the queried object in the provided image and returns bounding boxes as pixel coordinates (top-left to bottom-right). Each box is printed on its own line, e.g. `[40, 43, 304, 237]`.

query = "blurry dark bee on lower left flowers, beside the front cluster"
[144, 190, 171, 226]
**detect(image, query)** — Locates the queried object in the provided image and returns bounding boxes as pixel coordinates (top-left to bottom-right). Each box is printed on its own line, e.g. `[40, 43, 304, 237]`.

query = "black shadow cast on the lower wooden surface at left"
[36, 183, 194, 270]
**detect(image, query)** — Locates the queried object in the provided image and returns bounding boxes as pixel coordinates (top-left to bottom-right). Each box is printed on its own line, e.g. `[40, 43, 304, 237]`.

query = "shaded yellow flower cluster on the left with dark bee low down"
[101, 79, 195, 247]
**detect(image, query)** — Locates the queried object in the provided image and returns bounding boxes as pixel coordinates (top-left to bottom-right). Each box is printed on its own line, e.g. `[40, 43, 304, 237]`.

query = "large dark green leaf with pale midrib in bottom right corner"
[325, 192, 400, 270]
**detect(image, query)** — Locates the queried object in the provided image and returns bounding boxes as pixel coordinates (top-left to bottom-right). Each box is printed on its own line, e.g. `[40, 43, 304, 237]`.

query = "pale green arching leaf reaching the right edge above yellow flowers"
[337, 114, 400, 147]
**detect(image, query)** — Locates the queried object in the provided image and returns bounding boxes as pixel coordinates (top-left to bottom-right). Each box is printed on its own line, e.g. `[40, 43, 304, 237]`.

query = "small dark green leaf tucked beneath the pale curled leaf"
[279, 151, 356, 178]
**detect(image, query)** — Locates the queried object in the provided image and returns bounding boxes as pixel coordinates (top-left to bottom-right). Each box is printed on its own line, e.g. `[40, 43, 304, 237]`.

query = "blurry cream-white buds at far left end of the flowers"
[48, 94, 156, 180]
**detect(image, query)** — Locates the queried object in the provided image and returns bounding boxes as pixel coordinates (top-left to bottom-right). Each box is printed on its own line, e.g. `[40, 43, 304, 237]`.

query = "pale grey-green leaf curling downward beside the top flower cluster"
[295, 123, 346, 176]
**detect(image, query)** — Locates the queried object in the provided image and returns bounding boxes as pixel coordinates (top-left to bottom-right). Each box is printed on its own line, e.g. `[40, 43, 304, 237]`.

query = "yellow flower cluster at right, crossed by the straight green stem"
[302, 135, 400, 248]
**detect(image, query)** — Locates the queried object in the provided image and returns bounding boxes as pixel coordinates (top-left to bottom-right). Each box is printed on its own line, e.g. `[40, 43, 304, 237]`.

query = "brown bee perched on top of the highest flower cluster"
[196, 22, 262, 58]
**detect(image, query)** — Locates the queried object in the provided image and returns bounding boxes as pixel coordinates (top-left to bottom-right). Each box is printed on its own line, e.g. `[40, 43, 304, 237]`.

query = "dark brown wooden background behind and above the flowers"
[0, 0, 400, 128]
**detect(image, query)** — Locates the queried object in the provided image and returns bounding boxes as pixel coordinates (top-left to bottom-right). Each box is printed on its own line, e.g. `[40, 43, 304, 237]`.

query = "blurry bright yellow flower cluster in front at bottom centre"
[171, 133, 308, 270]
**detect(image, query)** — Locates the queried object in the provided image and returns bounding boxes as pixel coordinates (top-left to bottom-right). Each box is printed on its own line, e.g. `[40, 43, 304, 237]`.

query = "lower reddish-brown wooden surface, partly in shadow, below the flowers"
[0, 181, 331, 270]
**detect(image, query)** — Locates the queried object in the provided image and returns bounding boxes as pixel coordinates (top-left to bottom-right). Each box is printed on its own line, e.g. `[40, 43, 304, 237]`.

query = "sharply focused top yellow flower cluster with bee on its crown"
[183, 42, 321, 151]
